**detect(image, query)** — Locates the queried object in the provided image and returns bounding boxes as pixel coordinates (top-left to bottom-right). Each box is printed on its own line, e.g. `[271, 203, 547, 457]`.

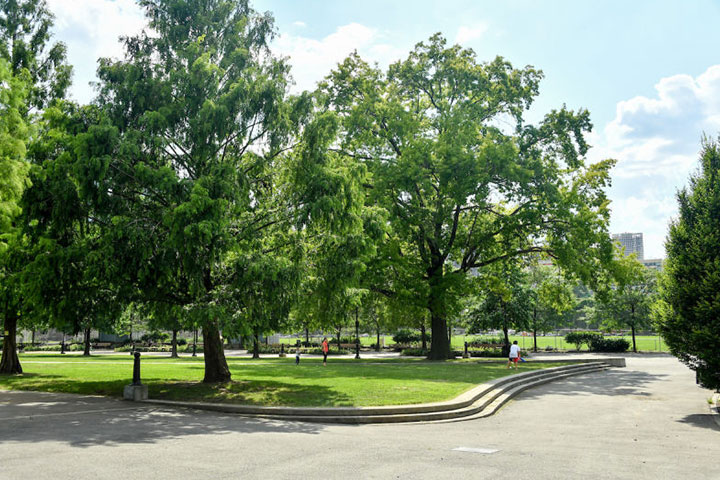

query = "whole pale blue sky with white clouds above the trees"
[47, 0, 720, 258]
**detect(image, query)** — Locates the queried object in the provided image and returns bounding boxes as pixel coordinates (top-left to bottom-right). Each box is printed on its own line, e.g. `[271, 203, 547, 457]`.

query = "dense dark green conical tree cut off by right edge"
[657, 139, 720, 389]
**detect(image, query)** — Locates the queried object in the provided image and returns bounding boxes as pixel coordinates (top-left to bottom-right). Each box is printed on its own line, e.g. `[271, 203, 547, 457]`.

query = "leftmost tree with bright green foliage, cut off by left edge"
[0, 0, 72, 373]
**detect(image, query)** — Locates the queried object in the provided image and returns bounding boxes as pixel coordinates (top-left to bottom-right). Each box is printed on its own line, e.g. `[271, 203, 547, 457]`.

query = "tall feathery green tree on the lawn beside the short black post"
[86, 0, 352, 382]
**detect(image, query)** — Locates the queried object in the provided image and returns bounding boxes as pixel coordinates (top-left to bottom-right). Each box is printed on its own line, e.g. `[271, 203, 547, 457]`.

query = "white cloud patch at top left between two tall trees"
[48, 0, 146, 103]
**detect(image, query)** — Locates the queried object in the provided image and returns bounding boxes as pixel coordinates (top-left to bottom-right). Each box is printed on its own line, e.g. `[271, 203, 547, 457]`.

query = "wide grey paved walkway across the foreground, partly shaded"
[0, 356, 720, 480]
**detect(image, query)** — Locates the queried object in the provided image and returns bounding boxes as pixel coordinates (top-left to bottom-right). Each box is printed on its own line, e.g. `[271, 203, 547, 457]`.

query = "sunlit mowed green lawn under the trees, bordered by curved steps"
[0, 354, 566, 406]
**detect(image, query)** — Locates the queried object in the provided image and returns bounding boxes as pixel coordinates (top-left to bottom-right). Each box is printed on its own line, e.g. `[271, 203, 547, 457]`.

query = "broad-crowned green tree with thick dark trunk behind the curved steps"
[321, 34, 613, 359]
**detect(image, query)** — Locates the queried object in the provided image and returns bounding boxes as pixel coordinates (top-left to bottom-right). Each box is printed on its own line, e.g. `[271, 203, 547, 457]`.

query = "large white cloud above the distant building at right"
[590, 65, 720, 257]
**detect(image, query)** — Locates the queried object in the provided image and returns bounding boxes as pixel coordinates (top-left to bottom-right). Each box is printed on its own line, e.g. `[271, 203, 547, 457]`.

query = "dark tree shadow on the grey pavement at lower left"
[0, 391, 324, 448]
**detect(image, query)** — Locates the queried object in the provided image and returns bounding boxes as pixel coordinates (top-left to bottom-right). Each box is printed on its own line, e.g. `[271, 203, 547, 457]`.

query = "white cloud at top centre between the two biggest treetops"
[273, 23, 407, 91]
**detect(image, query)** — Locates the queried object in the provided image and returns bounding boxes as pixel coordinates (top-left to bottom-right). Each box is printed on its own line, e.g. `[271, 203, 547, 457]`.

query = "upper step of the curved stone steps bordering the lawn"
[143, 362, 603, 419]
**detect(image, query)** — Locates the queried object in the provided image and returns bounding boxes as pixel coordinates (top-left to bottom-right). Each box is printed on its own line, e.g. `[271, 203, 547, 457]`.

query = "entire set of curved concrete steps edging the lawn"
[142, 358, 625, 424]
